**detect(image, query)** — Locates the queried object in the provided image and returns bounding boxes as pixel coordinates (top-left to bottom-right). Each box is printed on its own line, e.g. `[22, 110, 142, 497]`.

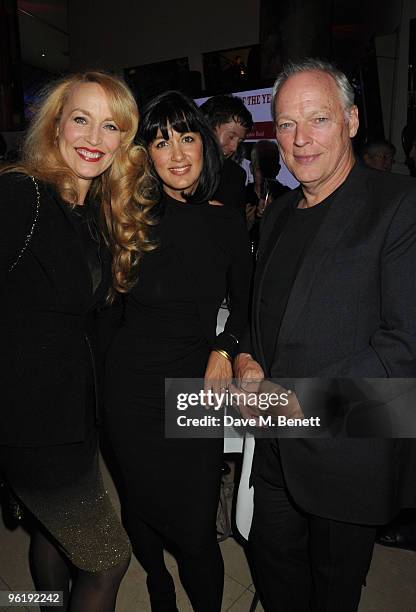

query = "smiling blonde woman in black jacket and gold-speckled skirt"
[0, 72, 151, 612]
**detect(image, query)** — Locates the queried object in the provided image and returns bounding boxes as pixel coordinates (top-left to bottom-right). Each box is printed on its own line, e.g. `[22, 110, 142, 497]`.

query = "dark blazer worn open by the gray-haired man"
[247, 165, 416, 524]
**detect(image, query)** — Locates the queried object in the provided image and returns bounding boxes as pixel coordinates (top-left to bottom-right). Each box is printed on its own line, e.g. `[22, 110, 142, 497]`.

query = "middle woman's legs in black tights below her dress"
[125, 517, 224, 612]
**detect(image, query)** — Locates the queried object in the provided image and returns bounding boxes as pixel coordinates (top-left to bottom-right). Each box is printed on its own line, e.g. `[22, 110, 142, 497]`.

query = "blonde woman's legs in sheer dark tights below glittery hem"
[30, 530, 129, 612]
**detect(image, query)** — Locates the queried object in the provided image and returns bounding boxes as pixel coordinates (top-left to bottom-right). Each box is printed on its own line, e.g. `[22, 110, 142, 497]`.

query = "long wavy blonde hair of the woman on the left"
[7, 71, 156, 298]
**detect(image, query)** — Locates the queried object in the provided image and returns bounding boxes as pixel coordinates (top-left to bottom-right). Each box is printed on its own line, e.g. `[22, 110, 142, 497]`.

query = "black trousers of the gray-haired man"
[249, 462, 376, 612]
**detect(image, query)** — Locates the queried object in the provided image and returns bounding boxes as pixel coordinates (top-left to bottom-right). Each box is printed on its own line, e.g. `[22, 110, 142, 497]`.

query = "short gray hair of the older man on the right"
[271, 57, 354, 121]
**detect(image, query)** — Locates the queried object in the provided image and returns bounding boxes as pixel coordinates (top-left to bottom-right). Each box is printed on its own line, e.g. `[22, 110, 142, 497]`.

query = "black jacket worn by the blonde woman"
[0, 174, 110, 446]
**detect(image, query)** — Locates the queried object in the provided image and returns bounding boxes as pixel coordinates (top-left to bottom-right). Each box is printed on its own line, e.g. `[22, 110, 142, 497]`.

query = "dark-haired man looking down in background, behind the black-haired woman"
[200, 95, 253, 214]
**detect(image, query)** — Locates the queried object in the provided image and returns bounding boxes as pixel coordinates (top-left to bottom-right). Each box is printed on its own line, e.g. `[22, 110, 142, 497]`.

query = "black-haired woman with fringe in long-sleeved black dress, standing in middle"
[107, 92, 250, 612]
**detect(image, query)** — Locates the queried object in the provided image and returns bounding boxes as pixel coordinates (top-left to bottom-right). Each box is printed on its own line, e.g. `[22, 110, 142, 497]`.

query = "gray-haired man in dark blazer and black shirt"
[235, 60, 416, 612]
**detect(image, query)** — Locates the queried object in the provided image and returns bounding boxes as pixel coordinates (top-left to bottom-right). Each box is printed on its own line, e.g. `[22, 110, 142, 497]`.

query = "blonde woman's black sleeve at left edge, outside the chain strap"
[0, 173, 38, 285]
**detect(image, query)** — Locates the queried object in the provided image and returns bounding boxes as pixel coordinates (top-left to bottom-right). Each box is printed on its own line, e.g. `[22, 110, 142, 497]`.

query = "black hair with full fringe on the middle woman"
[138, 91, 222, 204]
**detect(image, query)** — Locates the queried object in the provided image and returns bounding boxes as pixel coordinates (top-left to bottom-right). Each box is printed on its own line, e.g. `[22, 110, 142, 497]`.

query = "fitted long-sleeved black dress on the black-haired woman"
[107, 195, 250, 612]
